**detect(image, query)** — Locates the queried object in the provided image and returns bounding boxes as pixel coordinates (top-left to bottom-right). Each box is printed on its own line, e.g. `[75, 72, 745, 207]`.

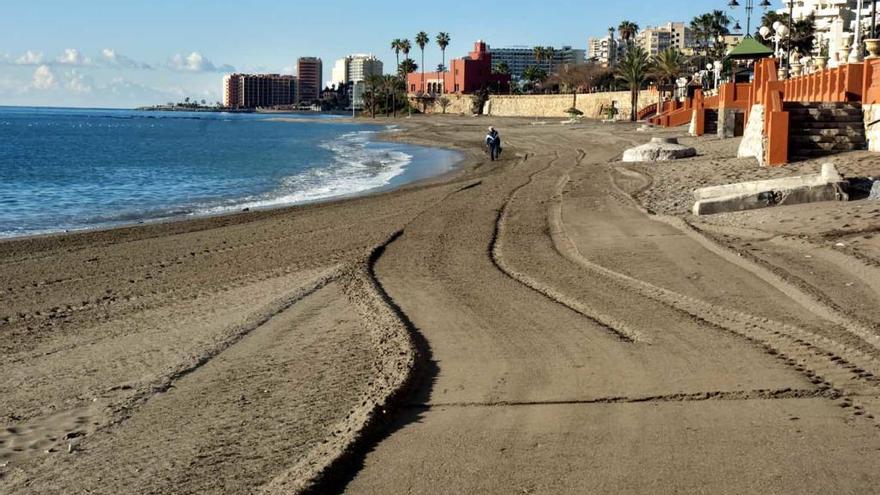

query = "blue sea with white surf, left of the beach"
[0, 107, 459, 237]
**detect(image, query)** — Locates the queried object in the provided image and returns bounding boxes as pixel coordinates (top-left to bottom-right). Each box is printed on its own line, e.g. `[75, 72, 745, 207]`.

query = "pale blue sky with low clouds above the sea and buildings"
[0, 0, 781, 107]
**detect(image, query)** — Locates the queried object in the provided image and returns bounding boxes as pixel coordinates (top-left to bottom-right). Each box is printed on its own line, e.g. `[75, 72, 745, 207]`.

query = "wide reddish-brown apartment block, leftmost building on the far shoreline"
[223, 74, 296, 108]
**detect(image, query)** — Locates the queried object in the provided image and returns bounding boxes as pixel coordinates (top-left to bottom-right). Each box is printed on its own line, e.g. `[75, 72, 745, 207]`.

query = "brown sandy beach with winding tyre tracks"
[0, 116, 880, 494]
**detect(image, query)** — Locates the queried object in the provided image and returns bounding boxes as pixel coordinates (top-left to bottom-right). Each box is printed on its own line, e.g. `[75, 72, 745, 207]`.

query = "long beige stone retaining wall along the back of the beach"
[416, 91, 657, 119]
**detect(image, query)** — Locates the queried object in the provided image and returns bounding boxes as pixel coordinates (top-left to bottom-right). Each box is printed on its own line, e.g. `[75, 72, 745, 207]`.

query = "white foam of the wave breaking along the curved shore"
[194, 131, 413, 215]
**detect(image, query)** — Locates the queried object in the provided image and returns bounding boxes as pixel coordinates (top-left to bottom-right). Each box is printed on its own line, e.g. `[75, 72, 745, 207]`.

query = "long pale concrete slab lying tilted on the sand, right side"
[693, 163, 849, 215]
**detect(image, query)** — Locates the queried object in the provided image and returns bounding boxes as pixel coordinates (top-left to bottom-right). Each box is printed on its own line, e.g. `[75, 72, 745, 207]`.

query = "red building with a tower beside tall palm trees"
[406, 41, 510, 95]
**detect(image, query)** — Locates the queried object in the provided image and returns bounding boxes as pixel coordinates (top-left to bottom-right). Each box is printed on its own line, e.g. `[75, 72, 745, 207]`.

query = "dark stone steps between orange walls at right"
[785, 102, 868, 160]
